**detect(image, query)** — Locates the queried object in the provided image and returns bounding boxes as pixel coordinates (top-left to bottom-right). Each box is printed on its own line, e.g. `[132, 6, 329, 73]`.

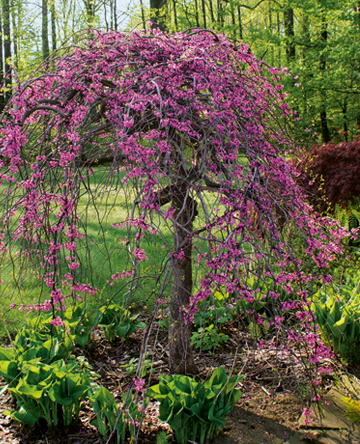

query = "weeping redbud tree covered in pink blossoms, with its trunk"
[0, 29, 339, 373]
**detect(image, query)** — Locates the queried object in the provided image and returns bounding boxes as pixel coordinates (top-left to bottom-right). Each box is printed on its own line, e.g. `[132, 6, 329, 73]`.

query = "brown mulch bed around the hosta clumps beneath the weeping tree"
[0, 325, 342, 444]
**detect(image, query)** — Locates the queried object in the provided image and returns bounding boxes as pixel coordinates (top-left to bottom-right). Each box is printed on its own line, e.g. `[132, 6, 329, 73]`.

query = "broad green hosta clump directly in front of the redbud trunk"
[147, 367, 243, 444]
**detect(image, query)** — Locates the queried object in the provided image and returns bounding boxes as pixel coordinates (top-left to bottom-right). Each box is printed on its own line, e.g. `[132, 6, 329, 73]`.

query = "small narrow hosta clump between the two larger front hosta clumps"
[89, 387, 141, 444]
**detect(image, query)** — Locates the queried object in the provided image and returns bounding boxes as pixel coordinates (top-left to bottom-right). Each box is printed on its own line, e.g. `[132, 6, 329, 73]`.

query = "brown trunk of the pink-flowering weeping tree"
[169, 194, 198, 374]
